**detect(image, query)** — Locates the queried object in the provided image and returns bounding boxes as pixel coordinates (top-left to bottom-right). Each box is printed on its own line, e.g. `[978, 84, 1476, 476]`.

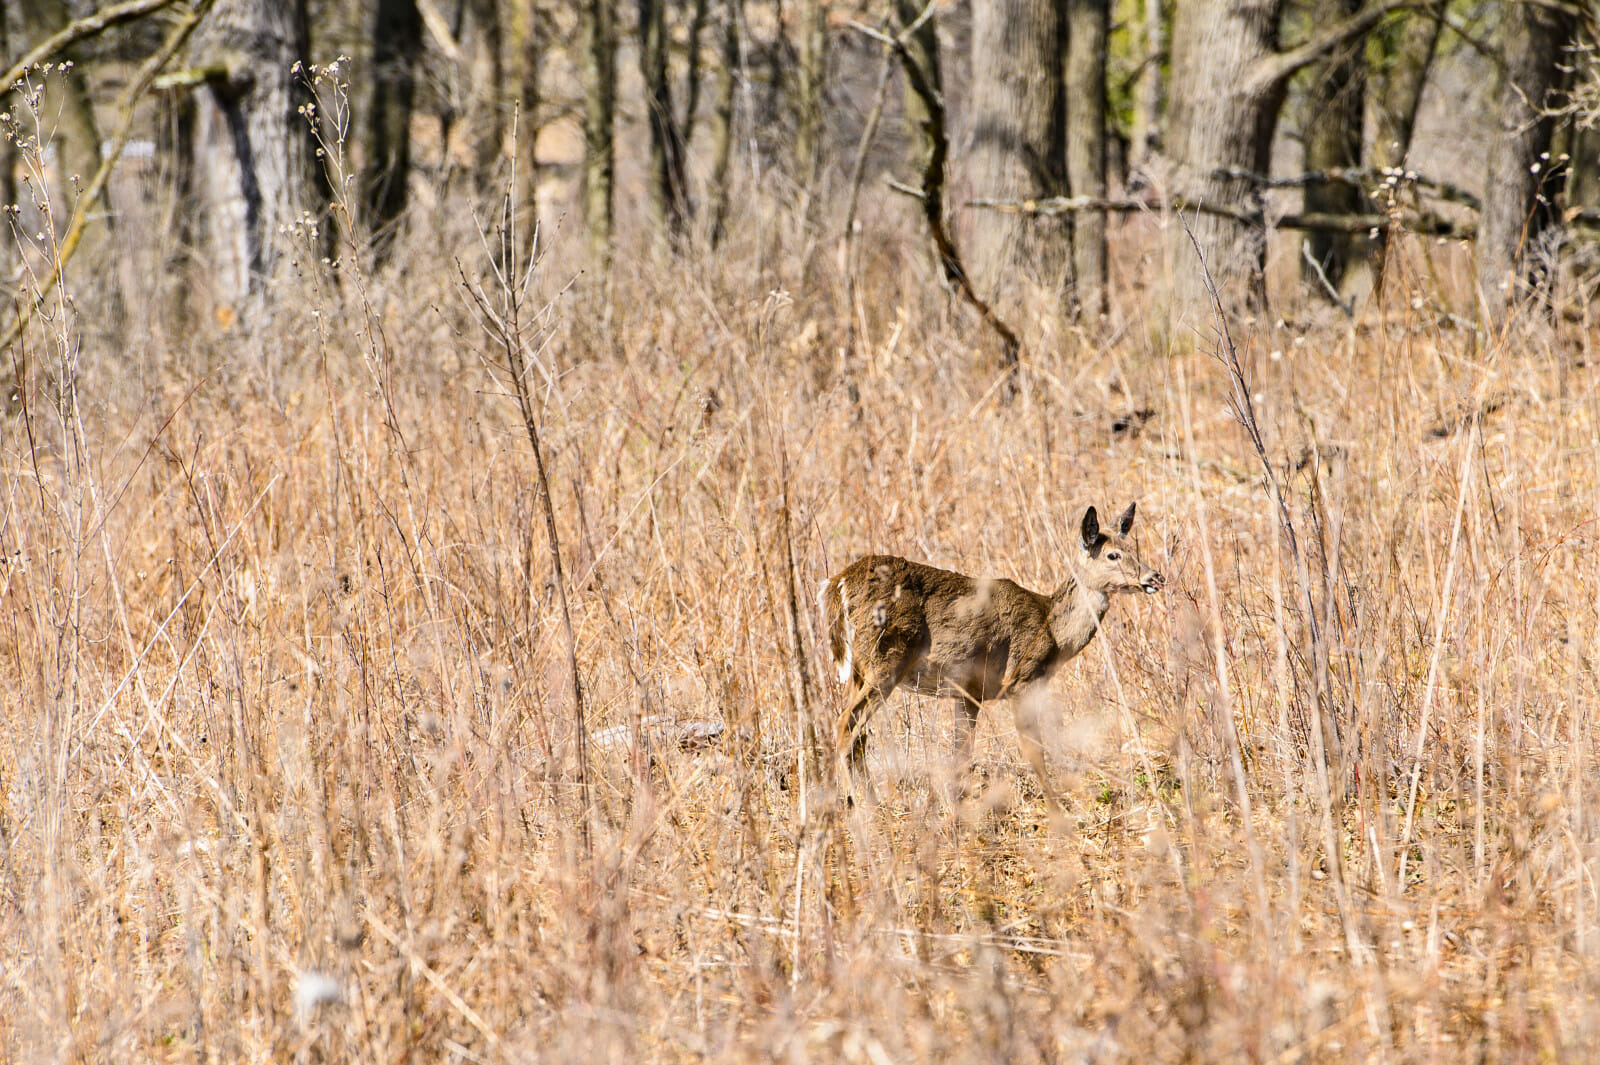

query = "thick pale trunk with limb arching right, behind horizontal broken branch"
[1166, 0, 1283, 313]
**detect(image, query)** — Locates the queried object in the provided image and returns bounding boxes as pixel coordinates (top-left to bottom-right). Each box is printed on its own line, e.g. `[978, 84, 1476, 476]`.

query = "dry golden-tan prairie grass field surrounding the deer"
[0, 186, 1600, 1063]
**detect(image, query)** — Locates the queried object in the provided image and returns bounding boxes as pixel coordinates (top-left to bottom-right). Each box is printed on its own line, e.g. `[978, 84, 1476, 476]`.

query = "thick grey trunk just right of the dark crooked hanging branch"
[966, 0, 1070, 317]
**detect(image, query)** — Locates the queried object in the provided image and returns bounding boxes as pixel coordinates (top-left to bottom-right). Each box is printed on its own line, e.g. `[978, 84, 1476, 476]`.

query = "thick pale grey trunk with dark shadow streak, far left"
[195, 0, 331, 310]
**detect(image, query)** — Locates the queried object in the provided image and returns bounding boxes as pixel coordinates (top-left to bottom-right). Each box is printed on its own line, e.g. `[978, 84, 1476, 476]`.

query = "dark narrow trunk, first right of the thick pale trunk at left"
[362, 0, 422, 262]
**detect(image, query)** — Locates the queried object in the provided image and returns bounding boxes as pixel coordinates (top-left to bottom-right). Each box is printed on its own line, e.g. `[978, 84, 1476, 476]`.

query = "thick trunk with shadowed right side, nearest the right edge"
[1475, 3, 1574, 323]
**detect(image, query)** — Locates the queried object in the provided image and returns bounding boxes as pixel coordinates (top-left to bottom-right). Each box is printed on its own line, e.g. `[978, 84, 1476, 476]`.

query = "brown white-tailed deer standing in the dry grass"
[818, 505, 1165, 816]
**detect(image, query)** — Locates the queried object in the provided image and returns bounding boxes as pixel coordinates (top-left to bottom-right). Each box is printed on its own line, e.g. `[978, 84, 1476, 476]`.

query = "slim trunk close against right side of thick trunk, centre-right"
[1064, 0, 1110, 321]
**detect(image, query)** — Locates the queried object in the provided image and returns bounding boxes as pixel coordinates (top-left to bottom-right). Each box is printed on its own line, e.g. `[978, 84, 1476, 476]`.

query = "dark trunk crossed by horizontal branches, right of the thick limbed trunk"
[1301, 0, 1366, 301]
